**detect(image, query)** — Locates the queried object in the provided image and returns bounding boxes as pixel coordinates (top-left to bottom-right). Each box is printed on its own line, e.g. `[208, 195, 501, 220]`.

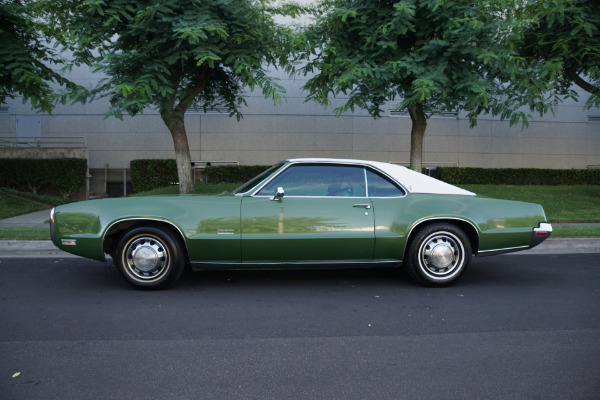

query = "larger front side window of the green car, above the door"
[256, 165, 366, 197]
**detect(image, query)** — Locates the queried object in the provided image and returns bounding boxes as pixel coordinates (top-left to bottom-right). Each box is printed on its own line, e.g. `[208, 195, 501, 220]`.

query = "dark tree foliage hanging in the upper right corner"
[520, 0, 600, 107]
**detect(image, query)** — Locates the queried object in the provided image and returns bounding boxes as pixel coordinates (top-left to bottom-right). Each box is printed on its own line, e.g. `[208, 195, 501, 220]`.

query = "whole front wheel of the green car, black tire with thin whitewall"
[113, 227, 185, 290]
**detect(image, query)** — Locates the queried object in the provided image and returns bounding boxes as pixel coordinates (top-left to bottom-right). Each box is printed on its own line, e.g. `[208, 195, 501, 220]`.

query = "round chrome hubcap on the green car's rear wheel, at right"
[419, 231, 465, 279]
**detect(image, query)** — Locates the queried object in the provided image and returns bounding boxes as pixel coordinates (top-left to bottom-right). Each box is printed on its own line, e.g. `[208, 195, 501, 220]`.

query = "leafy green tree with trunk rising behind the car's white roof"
[299, 0, 557, 172]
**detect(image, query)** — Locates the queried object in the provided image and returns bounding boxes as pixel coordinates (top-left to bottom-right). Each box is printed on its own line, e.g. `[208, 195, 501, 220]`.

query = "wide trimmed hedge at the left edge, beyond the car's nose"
[0, 158, 87, 199]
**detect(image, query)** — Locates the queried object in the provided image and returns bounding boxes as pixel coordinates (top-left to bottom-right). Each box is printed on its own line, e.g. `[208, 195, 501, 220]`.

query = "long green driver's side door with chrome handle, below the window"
[242, 196, 375, 263]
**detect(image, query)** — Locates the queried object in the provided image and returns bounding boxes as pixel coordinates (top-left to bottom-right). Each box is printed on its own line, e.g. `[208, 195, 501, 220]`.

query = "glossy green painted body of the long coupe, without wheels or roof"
[51, 160, 551, 280]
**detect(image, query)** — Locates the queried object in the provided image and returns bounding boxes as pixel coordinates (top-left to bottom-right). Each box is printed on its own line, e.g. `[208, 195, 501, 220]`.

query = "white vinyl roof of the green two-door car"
[288, 158, 475, 196]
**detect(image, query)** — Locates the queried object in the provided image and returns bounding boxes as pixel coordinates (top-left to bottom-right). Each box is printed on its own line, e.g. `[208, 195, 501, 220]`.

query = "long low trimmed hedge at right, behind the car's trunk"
[434, 167, 600, 185]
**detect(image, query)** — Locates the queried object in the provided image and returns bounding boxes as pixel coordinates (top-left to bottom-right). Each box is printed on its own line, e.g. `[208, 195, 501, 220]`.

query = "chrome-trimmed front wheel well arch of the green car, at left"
[102, 218, 189, 264]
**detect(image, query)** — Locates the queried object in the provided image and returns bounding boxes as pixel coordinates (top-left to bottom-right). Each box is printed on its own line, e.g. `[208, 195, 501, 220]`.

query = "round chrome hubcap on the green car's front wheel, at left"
[125, 236, 169, 280]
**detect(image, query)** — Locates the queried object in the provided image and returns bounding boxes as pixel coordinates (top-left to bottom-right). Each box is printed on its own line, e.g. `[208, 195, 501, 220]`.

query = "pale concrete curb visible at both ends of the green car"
[0, 238, 600, 258]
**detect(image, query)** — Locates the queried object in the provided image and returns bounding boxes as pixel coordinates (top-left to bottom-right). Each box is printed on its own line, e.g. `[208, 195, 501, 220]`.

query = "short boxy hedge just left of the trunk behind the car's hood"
[129, 159, 179, 193]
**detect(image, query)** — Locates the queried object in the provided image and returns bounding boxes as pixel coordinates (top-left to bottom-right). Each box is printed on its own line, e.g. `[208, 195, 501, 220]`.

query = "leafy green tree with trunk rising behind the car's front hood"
[63, 0, 296, 193]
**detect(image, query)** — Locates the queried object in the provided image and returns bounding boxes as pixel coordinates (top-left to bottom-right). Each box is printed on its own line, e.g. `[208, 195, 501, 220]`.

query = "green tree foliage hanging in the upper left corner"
[0, 0, 77, 112]
